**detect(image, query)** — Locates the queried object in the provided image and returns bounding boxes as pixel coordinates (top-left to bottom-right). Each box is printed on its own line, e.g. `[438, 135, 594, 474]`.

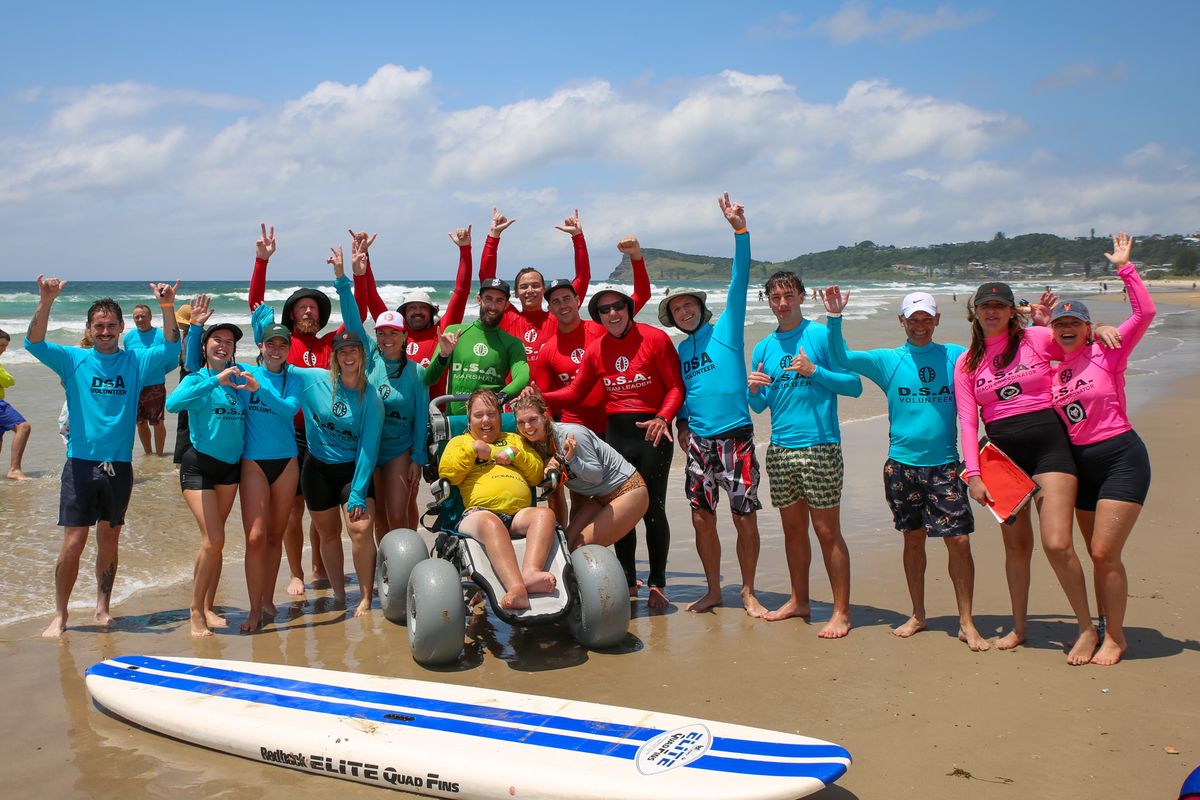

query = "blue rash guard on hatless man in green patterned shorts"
[749, 319, 863, 450]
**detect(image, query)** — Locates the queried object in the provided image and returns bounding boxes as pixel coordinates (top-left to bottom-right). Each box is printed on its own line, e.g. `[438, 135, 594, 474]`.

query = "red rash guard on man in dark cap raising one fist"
[529, 260, 650, 434]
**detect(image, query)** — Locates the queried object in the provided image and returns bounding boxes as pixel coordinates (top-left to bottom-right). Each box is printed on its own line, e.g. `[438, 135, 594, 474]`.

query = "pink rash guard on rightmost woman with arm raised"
[1052, 264, 1154, 445]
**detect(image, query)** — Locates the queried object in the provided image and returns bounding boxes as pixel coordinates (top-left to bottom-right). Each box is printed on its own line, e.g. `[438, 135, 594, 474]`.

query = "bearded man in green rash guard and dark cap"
[425, 278, 529, 414]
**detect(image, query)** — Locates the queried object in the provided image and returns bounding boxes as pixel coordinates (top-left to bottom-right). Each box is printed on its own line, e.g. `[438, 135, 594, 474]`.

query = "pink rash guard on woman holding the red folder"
[954, 327, 1062, 479]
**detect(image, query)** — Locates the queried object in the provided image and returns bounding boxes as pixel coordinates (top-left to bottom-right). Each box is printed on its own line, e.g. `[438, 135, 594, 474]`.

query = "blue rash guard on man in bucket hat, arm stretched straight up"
[679, 233, 750, 438]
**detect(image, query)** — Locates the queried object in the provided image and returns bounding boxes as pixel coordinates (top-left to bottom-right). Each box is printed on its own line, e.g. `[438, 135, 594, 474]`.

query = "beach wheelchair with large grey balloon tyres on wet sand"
[376, 395, 630, 666]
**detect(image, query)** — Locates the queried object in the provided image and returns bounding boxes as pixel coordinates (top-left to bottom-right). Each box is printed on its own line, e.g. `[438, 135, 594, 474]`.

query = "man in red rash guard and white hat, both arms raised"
[350, 225, 474, 398]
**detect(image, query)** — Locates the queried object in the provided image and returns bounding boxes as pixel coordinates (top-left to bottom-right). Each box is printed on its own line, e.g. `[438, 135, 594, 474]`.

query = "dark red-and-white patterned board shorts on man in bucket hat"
[683, 425, 762, 516]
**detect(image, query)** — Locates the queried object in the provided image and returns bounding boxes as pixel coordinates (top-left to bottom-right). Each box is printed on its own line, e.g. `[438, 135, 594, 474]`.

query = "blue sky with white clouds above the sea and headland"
[0, 0, 1200, 281]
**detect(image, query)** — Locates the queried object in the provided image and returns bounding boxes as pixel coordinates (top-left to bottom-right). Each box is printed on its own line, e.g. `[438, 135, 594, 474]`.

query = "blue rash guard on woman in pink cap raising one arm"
[337, 286, 430, 467]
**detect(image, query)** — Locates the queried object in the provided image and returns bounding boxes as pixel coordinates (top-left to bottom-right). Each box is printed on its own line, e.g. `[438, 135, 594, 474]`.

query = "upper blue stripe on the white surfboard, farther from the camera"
[113, 656, 851, 759]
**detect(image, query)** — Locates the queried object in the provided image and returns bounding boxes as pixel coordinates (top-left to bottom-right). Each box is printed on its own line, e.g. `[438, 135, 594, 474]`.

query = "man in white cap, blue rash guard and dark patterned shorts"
[821, 285, 991, 651]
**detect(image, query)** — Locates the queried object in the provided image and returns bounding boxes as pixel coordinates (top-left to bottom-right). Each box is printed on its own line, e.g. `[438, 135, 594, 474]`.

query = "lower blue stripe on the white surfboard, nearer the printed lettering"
[86, 662, 846, 784]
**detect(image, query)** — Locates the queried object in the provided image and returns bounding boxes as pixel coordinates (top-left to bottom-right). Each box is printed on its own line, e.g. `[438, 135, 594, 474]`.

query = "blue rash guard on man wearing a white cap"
[828, 317, 966, 467]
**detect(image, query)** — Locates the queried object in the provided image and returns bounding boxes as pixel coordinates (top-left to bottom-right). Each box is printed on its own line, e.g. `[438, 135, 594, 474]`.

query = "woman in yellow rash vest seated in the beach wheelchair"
[438, 390, 556, 610]
